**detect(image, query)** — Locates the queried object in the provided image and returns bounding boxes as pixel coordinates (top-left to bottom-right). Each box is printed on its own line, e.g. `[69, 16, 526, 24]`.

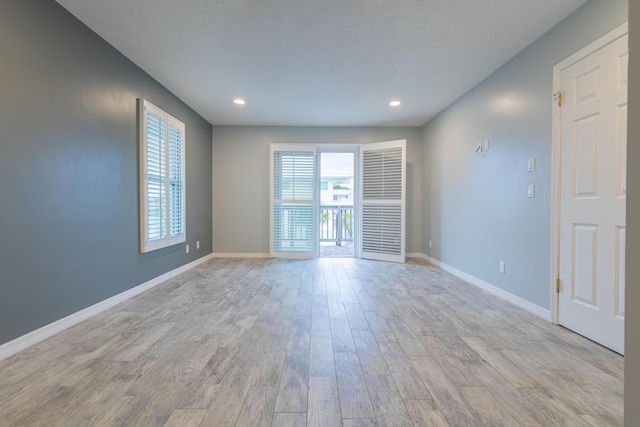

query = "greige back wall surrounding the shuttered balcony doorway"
[213, 126, 422, 254]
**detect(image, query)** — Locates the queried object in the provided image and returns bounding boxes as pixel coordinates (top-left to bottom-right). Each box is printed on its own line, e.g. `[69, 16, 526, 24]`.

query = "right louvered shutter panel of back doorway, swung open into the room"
[360, 140, 406, 262]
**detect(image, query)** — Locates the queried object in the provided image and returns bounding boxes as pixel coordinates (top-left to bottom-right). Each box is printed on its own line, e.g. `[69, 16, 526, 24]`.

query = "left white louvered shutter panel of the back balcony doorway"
[270, 144, 315, 258]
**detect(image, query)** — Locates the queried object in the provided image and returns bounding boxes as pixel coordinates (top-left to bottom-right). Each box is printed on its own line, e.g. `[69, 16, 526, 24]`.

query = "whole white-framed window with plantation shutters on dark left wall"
[139, 101, 186, 252]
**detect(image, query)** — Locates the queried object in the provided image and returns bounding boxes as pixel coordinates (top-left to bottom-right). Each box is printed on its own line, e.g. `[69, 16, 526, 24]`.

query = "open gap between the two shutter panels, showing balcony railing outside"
[316, 147, 358, 258]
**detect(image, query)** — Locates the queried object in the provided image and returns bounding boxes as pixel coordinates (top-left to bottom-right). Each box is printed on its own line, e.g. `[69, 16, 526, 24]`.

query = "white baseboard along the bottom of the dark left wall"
[0, 254, 213, 360]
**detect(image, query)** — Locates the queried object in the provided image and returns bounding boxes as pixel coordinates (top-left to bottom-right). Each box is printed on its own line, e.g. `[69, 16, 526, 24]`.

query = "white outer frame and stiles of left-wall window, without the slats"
[138, 100, 187, 253]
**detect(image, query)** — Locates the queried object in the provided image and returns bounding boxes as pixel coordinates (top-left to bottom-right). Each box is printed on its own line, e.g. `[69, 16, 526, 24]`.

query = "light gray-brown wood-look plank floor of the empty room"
[0, 258, 623, 427]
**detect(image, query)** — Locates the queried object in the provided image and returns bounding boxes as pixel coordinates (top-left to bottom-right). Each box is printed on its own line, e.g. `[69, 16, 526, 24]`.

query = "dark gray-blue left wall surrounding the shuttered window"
[0, 0, 212, 344]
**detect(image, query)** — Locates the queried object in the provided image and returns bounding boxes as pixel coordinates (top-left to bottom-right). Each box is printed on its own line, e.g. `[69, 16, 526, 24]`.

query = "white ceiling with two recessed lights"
[57, 0, 586, 126]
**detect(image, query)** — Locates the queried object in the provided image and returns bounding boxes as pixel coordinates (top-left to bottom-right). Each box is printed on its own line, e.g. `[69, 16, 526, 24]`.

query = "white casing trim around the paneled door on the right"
[550, 22, 629, 324]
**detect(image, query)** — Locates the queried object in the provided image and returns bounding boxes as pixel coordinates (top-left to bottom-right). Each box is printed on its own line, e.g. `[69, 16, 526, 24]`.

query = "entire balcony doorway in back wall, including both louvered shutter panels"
[269, 140, 406, 262]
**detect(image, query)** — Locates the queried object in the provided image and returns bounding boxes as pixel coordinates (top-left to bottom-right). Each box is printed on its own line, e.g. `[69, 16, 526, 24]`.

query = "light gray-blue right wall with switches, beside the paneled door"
[422, 0, 628, 309]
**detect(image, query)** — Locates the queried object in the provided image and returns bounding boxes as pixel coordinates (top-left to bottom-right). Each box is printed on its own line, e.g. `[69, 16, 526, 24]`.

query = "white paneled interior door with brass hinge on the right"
[558, 35, 628, 353]
